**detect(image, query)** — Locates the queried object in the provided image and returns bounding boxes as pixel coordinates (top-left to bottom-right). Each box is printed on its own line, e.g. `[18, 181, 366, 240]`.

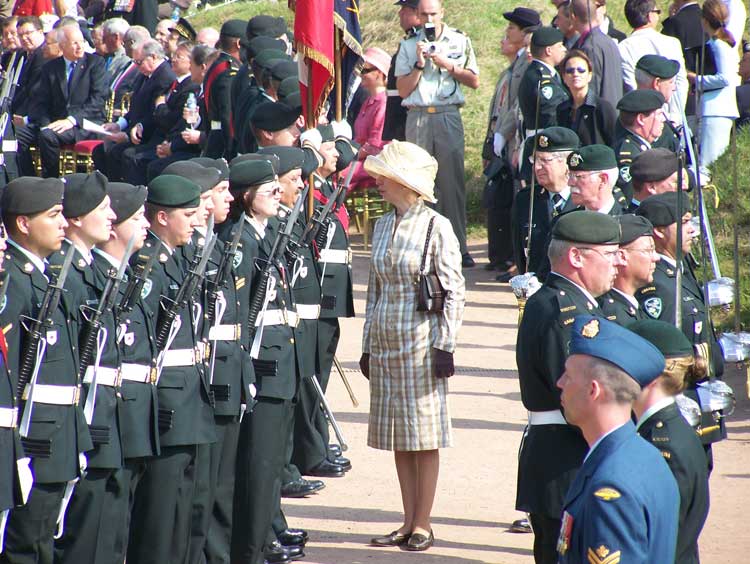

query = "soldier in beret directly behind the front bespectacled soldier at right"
[598, 214, 659, 327]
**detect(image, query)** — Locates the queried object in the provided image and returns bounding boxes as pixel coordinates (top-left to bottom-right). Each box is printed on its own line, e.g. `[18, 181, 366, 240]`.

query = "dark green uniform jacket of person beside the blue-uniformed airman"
[638, 403, 709, 564]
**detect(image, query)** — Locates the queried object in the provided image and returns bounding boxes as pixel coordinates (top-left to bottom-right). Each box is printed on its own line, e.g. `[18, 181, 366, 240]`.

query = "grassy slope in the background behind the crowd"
[191, 0, 750, 326]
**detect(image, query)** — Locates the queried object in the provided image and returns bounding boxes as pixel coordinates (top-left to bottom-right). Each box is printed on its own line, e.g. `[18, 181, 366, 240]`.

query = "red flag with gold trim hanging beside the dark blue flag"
[294, 0, 334, 127]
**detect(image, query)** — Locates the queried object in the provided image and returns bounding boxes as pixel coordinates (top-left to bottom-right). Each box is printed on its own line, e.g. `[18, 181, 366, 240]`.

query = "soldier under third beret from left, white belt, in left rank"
[93, 182, 159, 562]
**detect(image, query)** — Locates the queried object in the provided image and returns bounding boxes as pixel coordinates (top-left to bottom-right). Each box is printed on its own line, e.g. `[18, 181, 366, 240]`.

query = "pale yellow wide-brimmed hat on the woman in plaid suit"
[365, 140, 437, 204]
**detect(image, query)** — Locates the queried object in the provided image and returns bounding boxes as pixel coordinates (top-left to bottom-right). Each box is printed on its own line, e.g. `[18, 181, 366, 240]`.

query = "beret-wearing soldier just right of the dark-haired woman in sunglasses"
[615, 90, 666, 203]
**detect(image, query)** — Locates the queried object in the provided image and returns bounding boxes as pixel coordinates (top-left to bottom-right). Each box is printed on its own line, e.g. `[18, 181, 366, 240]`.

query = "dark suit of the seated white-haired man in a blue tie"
[19, 53, 109, 177]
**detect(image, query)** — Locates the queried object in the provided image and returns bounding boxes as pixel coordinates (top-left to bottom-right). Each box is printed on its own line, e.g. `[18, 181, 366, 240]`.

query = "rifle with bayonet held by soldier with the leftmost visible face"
[16, 247, 75, 403]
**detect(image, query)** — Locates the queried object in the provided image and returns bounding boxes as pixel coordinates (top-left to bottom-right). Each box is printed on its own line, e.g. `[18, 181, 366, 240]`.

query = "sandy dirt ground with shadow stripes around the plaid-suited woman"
[284, 236, 750, 564]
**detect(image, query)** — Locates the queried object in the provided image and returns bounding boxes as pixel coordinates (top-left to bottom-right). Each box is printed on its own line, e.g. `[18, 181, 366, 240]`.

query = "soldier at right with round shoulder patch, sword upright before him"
[636, 192, 726, 471]
